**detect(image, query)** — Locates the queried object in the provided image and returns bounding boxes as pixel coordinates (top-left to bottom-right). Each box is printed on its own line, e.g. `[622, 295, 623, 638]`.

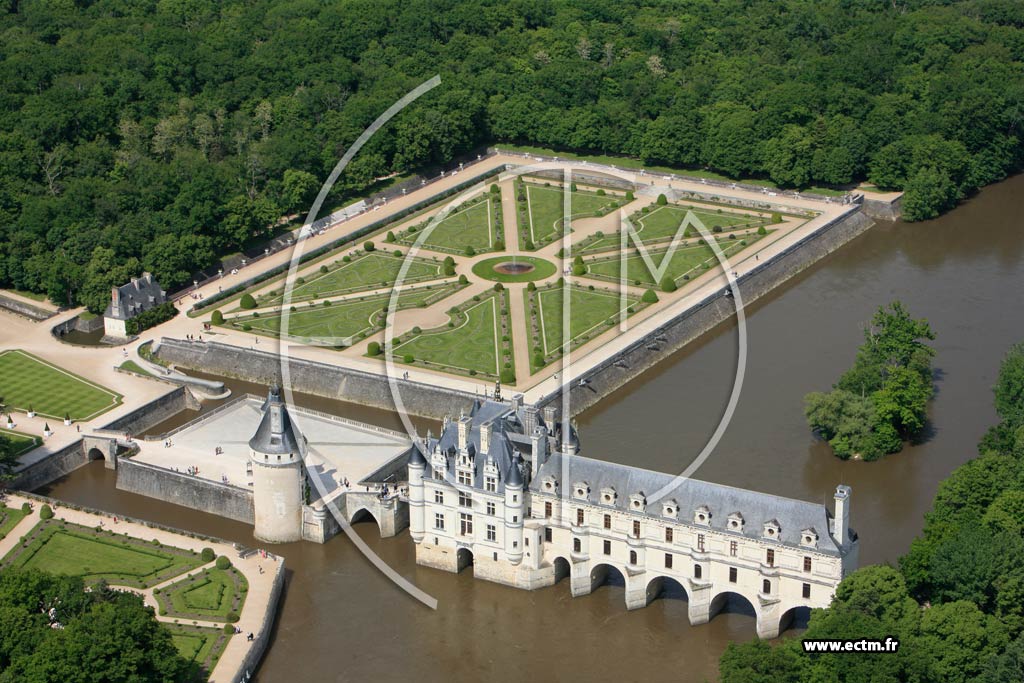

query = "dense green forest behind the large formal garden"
[0, 0, 1024, 310]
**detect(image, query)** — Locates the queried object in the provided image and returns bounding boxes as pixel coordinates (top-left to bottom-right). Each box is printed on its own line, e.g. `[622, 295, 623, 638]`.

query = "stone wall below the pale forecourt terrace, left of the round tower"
[117, 458, 255, 524]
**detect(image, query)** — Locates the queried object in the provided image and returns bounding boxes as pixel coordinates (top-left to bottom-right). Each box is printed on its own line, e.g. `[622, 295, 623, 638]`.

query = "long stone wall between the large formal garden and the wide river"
[538, 208, 874, 415]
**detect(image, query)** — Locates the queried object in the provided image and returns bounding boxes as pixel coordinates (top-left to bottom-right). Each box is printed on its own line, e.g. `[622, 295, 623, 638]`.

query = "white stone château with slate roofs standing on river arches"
[409, 398, 858, 638]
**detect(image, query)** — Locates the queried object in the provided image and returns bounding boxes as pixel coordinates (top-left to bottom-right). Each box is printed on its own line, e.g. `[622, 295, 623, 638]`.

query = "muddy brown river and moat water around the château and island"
[36, 176, 1024, 683]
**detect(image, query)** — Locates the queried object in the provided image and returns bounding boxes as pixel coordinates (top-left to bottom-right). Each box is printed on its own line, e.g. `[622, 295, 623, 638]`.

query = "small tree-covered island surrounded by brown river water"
[804, 301, 935, 460]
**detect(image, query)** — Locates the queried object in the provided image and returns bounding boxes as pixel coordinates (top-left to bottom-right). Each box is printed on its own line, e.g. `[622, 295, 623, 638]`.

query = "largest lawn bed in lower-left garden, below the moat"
[8, 521, 202, 588]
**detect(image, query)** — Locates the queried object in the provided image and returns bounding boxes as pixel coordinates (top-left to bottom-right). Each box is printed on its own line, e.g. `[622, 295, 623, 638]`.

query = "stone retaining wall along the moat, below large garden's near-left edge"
[157, 338, 475, 419]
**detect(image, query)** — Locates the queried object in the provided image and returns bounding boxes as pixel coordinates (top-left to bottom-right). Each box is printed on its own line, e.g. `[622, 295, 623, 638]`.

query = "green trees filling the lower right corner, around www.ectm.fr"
[721, 344, 1024, 683]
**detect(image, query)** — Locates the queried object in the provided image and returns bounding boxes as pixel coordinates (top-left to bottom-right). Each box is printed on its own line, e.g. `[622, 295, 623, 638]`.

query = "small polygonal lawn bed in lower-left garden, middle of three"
[157, 567, 246, 622]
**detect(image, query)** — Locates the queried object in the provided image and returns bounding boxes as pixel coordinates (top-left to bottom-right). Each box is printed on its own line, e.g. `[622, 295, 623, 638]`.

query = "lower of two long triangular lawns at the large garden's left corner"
[231, 284, 459, 345]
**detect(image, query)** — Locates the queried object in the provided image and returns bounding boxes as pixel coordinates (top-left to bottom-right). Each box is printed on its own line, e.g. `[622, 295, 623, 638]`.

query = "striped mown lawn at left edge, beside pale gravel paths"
[0, 349, 121, 420]
